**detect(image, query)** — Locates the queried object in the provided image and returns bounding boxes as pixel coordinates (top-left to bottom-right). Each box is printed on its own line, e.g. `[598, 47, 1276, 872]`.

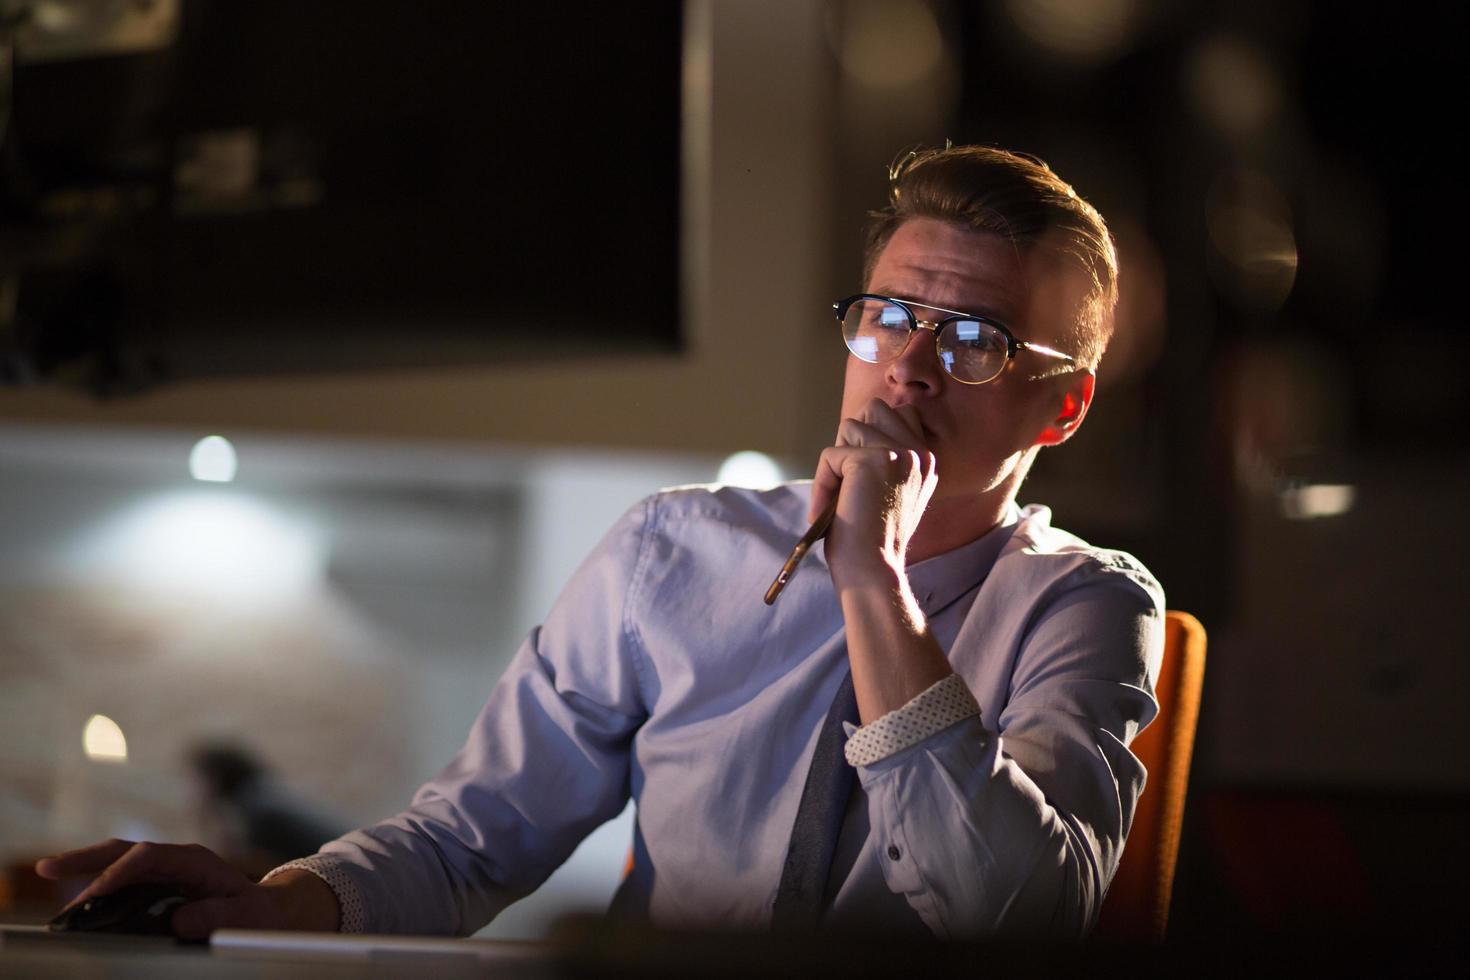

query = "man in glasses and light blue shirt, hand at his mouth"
[38, 147, 1163, 937]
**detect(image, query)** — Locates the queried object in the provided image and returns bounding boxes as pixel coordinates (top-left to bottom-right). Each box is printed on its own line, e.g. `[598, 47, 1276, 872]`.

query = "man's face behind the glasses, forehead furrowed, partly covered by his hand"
[842, 217, 1091, 501]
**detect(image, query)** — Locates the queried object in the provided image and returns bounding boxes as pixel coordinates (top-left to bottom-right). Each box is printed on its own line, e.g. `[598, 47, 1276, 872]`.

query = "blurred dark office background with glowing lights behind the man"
[0, 0, 1470, 936]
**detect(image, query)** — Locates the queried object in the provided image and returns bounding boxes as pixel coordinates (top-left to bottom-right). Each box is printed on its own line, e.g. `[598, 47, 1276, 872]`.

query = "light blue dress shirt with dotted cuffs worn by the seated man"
[313, 483, 1163, 937]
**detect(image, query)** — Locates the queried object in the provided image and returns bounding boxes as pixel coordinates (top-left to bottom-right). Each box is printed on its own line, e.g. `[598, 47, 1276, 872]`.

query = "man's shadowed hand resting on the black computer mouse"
[35, 840, 340, 940]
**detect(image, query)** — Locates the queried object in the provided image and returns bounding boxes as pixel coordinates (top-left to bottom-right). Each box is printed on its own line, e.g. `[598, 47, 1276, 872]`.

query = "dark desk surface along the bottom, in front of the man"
[0, 918, 1422, 980]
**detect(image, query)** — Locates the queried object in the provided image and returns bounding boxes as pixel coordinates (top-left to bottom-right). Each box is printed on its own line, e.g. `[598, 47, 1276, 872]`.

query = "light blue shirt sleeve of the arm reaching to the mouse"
[286, 500, 654, 934]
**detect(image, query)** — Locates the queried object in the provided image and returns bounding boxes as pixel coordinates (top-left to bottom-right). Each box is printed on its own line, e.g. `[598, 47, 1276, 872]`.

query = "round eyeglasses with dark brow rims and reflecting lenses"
[832, 292, 1078, 385]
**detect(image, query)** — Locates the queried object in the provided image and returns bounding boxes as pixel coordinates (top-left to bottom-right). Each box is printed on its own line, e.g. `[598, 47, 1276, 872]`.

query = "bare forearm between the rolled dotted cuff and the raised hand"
[838, 564, 953, 724]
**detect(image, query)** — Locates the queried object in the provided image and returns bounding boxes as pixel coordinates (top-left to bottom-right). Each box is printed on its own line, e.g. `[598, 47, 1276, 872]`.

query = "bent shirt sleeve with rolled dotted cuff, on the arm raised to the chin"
[858, 569, 1163, 939]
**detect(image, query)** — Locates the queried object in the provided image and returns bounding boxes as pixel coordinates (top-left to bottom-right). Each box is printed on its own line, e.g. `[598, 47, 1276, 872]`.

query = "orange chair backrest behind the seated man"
[1094, 611, 1205, 942]
